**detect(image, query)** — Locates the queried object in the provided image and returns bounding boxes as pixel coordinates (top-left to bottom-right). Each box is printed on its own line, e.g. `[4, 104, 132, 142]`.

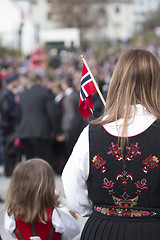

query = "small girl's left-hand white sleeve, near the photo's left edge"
[4, 212, 17, 239]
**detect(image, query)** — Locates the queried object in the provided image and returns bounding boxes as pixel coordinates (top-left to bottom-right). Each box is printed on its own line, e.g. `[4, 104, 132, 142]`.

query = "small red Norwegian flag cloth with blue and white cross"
[79, 63, 97, 120]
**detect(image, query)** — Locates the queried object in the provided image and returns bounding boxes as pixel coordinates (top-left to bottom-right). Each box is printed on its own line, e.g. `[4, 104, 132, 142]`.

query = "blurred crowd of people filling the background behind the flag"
[0, 42, 160, 176]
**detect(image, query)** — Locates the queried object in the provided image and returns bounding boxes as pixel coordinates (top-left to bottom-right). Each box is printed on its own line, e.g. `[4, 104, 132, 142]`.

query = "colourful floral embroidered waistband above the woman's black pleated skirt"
[94, 206, 157, 217]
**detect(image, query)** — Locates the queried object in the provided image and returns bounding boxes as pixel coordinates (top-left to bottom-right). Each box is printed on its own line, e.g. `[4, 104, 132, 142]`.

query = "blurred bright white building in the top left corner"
[0, 0, 35, 54]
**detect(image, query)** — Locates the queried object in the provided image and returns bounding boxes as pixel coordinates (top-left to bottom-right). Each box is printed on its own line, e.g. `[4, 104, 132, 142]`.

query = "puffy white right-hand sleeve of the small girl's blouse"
[52, 207, 81, 240]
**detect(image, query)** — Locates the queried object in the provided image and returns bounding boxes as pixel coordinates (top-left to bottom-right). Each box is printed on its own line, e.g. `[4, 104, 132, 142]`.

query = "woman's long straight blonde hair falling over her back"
[94, 49, 160, 156]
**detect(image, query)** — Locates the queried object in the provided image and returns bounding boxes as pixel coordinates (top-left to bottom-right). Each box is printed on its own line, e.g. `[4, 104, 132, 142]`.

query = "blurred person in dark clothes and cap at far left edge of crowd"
[0, 74, 19, 176]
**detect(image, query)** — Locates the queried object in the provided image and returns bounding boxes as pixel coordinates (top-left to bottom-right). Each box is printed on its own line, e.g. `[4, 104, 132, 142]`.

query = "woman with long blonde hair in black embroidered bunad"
[62, 49, 160, 240]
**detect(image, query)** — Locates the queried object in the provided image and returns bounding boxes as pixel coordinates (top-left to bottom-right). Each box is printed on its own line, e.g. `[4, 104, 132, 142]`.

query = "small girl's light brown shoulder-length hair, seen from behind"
[5, 159, 57, 223]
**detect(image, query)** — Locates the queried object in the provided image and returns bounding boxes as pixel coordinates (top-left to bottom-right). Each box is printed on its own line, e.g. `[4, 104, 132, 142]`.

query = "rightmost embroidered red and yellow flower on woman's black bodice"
[142, 154, 159, 173]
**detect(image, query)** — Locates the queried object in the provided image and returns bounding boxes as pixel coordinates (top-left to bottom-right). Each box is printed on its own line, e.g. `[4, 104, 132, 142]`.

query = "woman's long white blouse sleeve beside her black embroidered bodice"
[62, 126, 92, 216]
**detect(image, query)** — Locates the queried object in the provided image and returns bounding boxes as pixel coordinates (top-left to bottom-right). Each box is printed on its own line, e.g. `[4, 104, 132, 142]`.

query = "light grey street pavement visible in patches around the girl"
[0, 172, 86, 240]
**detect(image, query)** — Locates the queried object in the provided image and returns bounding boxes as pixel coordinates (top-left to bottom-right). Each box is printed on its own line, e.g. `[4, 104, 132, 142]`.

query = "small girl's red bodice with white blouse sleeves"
[4, 206, 80, 240]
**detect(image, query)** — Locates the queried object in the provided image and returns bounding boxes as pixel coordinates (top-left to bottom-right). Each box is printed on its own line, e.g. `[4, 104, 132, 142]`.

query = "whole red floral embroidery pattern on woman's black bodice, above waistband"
[92, 142, 159, 207]
